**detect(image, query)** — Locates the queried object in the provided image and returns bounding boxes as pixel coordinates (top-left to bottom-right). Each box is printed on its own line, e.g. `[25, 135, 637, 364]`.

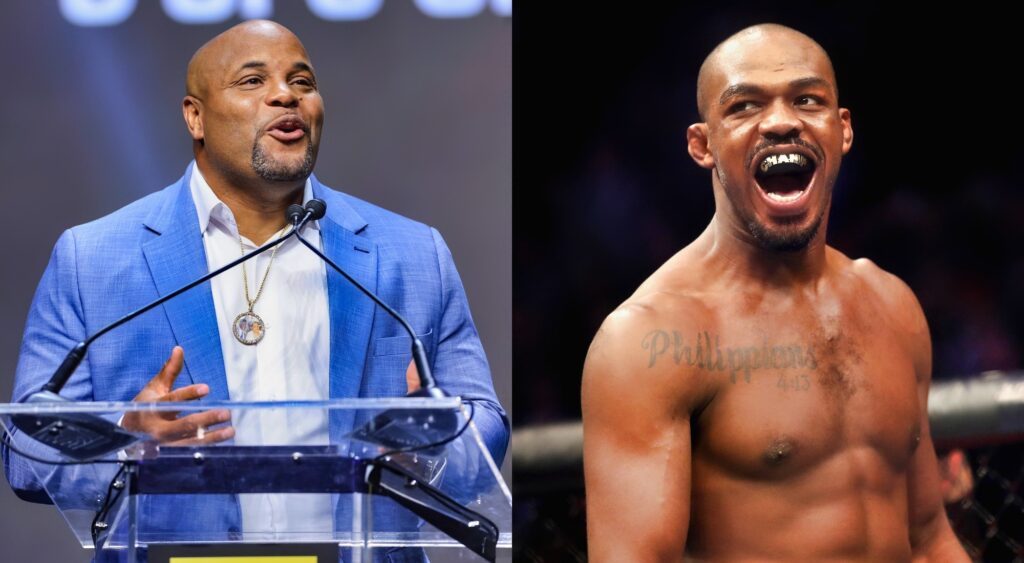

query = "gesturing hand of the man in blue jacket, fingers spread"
[121, 346, 234, 445]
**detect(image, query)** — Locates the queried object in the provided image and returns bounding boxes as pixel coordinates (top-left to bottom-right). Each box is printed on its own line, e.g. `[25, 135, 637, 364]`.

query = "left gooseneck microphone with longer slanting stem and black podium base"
[11, 205, 313, 461]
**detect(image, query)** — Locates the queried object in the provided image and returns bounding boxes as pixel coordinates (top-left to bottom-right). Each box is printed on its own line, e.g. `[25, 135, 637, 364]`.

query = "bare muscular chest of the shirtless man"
[644, 314, 922, 478]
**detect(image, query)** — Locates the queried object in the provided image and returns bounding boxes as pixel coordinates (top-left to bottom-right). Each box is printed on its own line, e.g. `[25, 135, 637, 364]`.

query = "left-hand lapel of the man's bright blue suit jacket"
[142, 170, 228, 400]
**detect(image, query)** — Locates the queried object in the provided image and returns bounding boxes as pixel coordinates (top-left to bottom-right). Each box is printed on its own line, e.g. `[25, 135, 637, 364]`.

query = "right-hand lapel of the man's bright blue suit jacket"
[312, 177, 377, 405]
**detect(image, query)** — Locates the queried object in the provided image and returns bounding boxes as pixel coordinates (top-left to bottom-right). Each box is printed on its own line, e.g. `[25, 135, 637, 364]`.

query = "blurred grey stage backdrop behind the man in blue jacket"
[0, 0, 512, 563]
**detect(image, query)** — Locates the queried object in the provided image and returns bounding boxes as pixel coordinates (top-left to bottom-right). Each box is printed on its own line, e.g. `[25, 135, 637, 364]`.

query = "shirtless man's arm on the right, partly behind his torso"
[897, 280, 971, 563]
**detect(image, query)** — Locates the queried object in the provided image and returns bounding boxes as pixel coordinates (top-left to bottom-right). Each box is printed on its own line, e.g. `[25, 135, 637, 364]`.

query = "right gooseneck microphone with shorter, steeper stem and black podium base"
[288, 200, 458, 451]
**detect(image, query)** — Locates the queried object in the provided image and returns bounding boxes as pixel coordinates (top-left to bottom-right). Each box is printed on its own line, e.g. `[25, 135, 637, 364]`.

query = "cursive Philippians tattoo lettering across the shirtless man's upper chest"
[640, 330, 818, 383]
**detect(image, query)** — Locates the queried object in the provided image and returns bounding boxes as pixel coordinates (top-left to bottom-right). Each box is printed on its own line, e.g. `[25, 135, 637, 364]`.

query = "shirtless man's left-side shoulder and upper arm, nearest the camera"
[582, 305, 709, 563]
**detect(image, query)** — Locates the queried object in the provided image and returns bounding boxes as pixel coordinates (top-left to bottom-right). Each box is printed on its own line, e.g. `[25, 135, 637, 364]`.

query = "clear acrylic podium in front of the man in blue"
[0, 397, 512, 562]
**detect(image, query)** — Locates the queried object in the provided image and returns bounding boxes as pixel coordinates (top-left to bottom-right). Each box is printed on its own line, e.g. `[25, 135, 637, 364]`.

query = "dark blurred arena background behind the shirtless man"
[513, 2, 1024, 561]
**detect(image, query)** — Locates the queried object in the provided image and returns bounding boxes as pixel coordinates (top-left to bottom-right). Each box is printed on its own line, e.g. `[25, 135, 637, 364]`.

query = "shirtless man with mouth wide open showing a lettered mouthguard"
[583, 25, 968, 563]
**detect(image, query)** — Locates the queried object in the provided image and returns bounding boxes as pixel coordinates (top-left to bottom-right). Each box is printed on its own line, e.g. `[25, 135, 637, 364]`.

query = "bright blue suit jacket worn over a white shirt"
[3, 166, 509, 560]
